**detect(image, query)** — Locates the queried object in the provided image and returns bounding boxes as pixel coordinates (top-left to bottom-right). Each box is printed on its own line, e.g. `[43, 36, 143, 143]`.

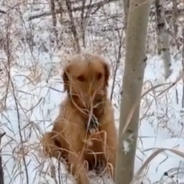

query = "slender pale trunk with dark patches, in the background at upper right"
[155, 0, 171, 79]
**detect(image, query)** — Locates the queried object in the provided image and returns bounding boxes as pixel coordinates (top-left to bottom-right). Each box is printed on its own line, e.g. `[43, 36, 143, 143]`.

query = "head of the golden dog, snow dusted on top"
[63, 54, 110, 108]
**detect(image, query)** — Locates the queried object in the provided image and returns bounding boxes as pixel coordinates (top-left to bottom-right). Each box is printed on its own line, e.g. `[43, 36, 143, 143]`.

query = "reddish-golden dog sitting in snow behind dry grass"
[41, 53, 117, 184]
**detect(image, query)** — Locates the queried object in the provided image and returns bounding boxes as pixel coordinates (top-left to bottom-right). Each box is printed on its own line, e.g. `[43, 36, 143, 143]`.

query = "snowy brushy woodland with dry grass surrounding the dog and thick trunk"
[0, 0, 184, 184]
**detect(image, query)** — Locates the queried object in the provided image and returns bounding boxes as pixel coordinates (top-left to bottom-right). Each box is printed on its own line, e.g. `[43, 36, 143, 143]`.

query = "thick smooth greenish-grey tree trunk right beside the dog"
[115, 0, 150, 184]
